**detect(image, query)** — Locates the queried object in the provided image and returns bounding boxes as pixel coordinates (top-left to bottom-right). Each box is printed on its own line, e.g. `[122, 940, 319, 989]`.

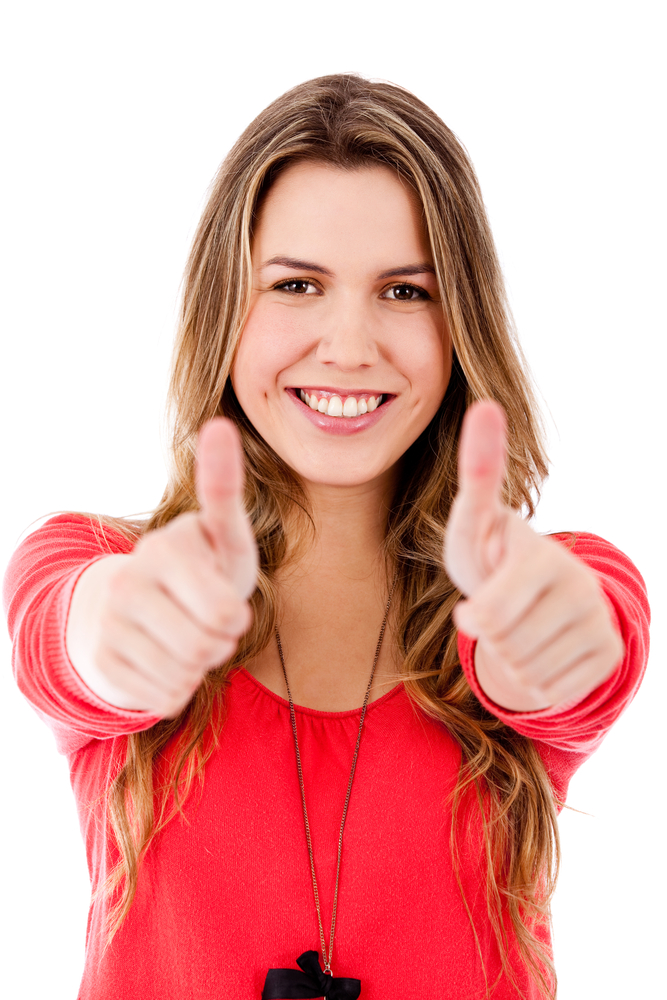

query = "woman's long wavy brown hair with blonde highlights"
[100, 74, 559, 997]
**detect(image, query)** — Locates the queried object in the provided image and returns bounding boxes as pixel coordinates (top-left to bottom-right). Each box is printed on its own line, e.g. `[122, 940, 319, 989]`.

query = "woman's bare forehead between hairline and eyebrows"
[253, 162, 430, 260]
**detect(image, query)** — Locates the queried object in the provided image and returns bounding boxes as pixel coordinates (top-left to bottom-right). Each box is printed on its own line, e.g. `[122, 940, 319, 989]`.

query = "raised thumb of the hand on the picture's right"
[457, 400, 507, 520]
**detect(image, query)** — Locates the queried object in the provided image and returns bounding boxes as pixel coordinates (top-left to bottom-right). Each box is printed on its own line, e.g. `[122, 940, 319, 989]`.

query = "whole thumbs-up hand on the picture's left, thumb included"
[67, 419, 257, 718]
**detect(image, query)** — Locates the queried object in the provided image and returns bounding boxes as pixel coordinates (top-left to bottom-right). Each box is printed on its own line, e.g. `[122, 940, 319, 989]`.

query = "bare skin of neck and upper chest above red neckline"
[246, 468, 400, 712]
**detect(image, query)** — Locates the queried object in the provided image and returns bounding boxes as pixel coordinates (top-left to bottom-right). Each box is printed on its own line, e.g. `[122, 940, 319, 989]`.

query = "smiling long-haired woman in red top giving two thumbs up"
[6, 76, 648, 1000]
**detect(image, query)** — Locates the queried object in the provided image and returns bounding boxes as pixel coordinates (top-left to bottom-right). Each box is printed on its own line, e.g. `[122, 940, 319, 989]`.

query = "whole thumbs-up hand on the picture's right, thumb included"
[445, 402, 624, 712]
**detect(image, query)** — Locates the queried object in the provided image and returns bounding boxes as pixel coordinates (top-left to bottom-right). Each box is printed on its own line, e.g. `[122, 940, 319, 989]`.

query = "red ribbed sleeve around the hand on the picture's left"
[3, 514, 158, 754]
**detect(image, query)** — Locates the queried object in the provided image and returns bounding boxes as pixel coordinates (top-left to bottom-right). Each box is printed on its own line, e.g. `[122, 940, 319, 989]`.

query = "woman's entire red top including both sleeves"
[5, 515, 648, 1000]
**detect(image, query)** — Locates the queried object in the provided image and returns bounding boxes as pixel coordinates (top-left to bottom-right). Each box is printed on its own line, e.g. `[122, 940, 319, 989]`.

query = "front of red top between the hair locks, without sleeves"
[79, 672, 528, 1000]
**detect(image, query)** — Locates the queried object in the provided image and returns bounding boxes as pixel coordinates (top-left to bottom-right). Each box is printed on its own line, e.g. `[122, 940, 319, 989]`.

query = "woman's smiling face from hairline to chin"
[232, 163, 451, 487]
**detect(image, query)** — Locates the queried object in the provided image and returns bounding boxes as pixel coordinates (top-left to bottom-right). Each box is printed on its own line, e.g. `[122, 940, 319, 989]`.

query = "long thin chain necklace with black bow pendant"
[262, 580, 396, 1000]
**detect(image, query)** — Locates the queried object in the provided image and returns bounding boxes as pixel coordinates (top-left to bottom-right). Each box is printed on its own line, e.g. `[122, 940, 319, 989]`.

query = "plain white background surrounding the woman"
[0, 0, 667, 1000]
